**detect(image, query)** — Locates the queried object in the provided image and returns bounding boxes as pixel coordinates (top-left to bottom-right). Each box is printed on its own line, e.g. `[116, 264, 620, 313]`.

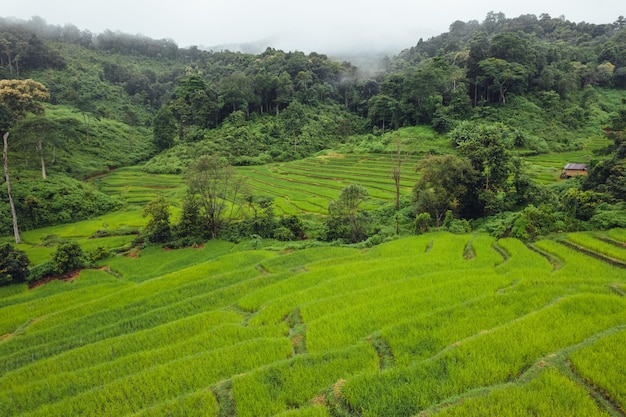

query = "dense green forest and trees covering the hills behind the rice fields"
[0, 12, 626, 276]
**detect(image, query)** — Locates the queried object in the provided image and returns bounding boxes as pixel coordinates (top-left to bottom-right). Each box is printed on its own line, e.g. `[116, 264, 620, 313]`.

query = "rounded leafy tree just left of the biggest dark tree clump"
[413, 155, 478, 227]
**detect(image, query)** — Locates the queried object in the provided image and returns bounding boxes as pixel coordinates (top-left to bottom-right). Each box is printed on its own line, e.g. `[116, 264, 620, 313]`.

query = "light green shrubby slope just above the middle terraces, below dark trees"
[144, 103, 362, 173]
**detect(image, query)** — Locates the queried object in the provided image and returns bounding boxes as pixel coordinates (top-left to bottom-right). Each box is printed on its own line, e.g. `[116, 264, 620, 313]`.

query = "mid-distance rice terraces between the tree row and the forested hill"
[92, 138, 609, 218]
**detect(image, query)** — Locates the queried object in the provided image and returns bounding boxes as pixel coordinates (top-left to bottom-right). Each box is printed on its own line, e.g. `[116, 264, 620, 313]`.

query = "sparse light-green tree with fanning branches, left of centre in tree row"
[187, 155, 243, 239]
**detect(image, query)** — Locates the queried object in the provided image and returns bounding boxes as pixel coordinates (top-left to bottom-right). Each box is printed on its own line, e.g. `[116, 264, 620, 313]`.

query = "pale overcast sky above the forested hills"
[0, 0, 626, 53]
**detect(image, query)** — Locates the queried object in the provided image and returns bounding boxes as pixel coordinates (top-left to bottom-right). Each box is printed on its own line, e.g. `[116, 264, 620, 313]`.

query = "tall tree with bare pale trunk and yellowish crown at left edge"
[0, 79, 50, 243]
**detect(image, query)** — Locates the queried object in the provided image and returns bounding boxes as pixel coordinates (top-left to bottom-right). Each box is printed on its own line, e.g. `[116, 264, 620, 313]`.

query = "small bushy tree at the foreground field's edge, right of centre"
[326, 184, 370, 243]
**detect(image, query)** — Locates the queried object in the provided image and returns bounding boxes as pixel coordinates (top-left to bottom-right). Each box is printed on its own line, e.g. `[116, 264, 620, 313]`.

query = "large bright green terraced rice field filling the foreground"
[0, 229, 626, 417]
